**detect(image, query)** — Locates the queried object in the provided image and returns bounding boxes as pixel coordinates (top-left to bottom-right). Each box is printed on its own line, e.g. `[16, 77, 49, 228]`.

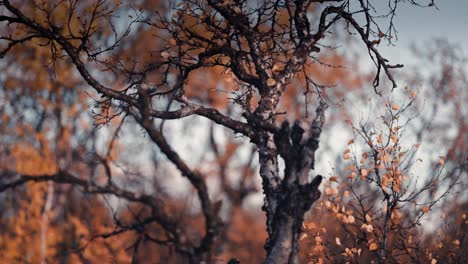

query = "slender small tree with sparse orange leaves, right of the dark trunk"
[305, 91, 465, 263]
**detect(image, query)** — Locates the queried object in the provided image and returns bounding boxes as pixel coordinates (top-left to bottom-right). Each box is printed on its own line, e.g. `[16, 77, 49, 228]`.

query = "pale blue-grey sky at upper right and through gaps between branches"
[110, 0, 468, 204]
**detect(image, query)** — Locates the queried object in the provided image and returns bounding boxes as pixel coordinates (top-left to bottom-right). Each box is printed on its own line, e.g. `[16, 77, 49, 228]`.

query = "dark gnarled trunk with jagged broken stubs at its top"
[257, 103, 326, 263]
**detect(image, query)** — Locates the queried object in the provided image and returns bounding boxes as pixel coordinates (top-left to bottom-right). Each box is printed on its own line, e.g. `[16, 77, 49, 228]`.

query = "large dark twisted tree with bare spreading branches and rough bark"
[0, 0, 450, 263]
